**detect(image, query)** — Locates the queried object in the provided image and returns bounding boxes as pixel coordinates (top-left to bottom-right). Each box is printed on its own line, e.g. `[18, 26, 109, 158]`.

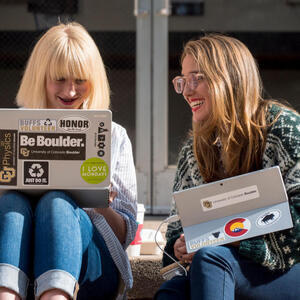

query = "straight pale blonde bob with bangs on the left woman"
[16, 22, 110, 109]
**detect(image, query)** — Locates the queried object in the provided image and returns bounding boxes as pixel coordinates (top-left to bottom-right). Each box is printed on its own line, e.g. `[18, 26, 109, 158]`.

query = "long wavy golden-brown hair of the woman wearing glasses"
[181, 34, 277, 182]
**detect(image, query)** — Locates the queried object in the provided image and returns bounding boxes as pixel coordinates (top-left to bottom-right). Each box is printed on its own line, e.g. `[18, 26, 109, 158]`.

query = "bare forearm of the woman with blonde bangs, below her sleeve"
[95, 207, 127, 244]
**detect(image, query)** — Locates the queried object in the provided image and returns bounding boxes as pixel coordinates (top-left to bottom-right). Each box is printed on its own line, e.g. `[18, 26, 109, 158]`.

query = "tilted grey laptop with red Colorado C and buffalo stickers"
[173, 166, 293, 253]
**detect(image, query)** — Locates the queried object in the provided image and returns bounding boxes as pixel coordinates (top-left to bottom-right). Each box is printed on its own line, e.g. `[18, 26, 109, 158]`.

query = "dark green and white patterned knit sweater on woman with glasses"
[163, 105, 300, 271]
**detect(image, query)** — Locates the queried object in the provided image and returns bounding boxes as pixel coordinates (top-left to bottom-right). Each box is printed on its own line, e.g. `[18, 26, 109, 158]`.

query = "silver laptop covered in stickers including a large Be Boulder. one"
[0, 109, 112, 207]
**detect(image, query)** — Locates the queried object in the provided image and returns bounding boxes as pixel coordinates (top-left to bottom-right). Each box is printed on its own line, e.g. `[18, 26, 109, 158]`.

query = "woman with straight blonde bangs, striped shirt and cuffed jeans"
[0, 23, 137, 300]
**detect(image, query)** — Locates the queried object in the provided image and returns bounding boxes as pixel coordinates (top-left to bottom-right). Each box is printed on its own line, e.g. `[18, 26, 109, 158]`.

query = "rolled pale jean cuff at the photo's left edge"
[0, 263, 29, 299]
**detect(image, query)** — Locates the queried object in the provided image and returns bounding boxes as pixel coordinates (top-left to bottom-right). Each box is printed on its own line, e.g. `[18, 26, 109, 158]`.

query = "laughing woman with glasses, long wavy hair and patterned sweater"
[155, 34, 300, 300]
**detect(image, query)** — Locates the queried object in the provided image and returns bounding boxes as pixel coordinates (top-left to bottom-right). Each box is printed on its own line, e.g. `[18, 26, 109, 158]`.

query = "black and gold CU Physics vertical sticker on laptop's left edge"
[0, 129, 18, 185]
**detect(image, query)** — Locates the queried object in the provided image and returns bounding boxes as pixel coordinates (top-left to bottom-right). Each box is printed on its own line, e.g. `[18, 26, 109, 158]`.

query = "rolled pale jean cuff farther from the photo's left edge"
[34, 270, 78, 299]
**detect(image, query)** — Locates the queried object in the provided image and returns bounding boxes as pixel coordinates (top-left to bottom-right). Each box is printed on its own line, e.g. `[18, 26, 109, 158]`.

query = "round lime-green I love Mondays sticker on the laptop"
[80, 157, 109, 184]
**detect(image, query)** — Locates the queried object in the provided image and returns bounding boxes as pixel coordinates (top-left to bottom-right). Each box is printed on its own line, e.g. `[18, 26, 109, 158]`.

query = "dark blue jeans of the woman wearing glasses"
[155, 246, 300, 300]
